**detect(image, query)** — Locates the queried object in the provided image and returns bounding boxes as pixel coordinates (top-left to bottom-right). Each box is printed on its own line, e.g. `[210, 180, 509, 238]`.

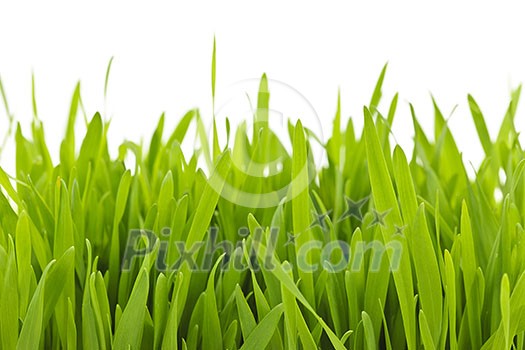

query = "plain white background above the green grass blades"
[0, 1, 525, 174]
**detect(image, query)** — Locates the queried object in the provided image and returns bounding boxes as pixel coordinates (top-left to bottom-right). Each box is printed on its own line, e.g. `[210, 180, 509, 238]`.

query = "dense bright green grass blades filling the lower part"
[0, 56, 525, 350]
